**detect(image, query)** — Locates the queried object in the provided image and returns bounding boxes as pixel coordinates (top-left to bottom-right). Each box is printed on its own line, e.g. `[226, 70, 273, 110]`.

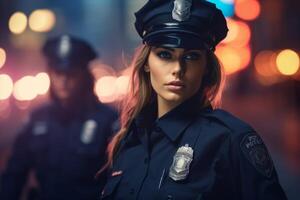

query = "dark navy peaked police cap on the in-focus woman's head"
[135, 0, 228, 50]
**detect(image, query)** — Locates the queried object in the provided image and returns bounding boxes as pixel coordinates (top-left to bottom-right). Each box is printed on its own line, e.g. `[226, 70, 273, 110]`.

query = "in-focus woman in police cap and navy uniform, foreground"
[102, 0, 286, 200]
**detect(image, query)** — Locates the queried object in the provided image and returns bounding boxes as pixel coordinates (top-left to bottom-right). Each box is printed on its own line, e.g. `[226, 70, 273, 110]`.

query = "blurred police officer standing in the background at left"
[0, 35, 117, 200]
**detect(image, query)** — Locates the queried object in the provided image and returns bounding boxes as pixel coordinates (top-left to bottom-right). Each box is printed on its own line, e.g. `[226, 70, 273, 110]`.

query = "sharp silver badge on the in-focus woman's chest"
[169, 144, 194, 181]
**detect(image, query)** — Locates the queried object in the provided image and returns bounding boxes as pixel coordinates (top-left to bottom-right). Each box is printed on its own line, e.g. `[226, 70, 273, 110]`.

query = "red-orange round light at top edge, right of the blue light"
[235, 0, 260, 21]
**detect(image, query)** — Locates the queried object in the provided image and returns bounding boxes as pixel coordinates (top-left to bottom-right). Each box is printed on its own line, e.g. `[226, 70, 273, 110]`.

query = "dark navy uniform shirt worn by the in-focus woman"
[102, 96, 286, 200]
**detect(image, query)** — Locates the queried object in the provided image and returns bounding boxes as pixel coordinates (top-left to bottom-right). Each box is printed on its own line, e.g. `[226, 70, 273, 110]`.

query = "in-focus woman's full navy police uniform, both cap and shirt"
[102, 0, 286, 200]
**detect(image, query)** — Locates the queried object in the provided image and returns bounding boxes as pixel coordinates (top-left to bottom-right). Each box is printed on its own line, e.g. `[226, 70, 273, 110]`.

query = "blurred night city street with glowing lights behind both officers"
[0, 0, 300, 200]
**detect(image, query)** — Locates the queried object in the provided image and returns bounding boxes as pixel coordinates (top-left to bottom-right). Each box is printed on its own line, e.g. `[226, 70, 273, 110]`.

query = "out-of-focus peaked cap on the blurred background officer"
[42, 35, 97, 71]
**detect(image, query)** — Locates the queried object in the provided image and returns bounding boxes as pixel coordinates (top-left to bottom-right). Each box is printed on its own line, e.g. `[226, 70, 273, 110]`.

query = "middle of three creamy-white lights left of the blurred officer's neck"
[13, 76, 38, 101]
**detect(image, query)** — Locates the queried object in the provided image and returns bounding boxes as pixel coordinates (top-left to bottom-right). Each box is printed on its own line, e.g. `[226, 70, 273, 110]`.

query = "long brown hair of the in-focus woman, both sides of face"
[100, 45, 224, 171]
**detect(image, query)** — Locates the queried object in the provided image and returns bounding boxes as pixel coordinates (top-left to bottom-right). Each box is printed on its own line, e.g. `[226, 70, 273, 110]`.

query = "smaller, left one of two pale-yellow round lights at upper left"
[8, 12, 27, 34]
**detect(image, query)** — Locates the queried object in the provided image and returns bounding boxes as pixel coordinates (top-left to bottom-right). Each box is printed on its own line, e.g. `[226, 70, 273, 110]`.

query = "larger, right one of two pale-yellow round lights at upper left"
[29, 9, 56, 32]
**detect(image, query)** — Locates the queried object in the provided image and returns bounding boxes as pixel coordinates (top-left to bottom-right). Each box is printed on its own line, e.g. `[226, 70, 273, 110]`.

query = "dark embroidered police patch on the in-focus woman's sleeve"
[240, 133, 274, 178]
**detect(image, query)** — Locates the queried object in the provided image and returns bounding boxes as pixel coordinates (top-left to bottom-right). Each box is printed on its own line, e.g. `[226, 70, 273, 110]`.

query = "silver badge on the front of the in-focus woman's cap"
[172, 0, 193, 22]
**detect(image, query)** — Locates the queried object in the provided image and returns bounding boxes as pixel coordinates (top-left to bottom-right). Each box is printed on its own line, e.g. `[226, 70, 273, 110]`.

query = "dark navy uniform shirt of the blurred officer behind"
[0, 101, 117, 200]
